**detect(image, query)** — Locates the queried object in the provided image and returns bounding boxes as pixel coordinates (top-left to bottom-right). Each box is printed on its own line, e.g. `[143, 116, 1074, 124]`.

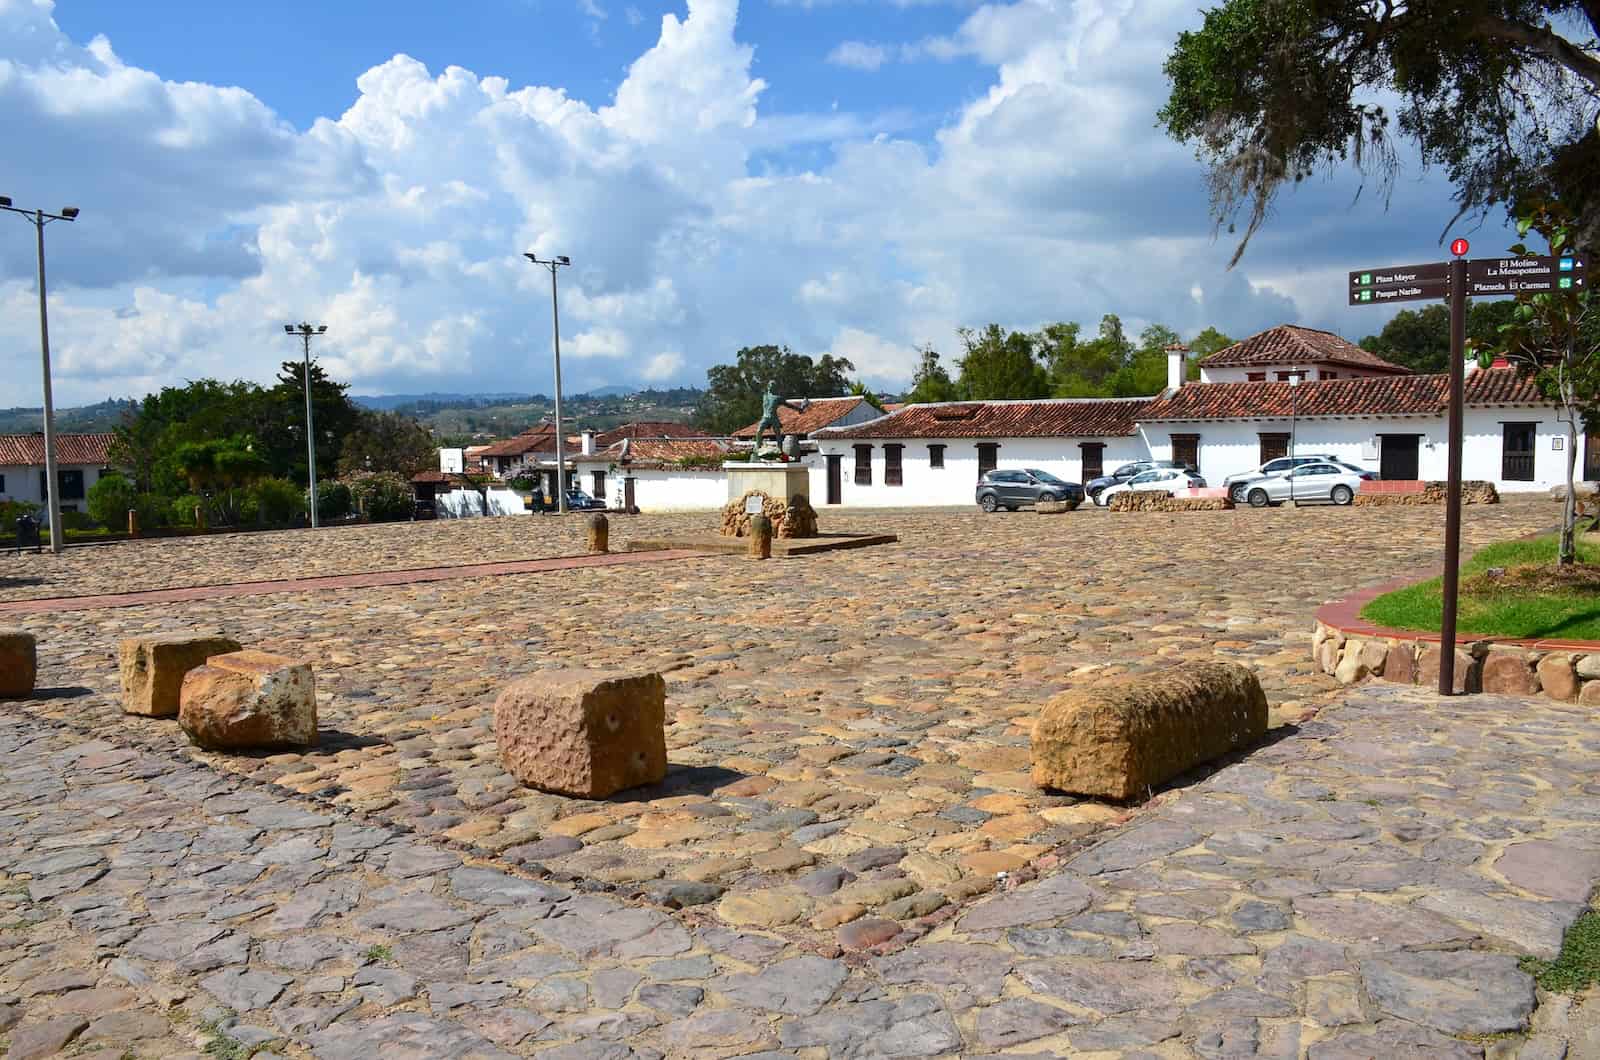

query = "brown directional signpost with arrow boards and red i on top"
[1349, 239, 1589, 695]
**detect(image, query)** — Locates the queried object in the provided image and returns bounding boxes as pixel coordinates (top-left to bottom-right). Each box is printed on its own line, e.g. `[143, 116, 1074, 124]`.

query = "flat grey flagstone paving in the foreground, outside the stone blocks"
[0, 685, 1600, 1060]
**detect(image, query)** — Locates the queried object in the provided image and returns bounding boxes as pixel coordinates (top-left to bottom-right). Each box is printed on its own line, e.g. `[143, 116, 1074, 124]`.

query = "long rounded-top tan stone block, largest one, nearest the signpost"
[1032, 663, 1267, 799]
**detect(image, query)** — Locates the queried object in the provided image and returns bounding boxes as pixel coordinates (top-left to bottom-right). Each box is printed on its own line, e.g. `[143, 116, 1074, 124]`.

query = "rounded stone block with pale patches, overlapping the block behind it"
[178, 652, 317, 751]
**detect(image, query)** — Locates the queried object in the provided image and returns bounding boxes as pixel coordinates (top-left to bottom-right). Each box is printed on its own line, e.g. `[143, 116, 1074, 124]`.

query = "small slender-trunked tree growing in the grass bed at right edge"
[1475, 203, 1600, 567]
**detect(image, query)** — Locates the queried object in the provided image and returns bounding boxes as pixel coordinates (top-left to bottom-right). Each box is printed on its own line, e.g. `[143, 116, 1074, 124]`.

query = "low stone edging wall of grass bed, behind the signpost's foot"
[1310, 621, 1600, 706]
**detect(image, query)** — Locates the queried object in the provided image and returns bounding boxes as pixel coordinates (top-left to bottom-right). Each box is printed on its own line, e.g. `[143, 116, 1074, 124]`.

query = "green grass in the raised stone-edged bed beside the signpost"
[1362, 533, 1600, 640]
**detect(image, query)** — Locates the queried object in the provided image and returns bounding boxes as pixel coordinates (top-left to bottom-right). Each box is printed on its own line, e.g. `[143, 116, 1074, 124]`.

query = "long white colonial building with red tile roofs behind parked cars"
[811, 325, 1574, 508]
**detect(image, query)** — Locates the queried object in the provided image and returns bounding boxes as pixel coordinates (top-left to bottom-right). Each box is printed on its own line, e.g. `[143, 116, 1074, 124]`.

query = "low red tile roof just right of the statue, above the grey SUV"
[821, 397, 1150, 439]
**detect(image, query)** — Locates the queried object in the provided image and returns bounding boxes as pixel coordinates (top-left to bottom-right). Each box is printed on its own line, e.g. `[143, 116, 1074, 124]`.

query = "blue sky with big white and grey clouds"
[0, 0, 1507, 405]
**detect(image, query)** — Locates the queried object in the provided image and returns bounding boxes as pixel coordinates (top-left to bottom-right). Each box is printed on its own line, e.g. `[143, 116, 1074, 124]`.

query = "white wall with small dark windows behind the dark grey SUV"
[811, 437, 1146, 509]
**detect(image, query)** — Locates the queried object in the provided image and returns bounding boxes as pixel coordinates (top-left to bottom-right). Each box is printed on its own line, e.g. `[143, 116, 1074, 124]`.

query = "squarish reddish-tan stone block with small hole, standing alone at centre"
[494, 669, 667, 799]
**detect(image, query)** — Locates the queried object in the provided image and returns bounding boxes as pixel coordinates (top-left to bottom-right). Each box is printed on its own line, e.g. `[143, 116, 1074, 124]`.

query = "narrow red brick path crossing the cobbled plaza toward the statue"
[0, 549, 706, 615]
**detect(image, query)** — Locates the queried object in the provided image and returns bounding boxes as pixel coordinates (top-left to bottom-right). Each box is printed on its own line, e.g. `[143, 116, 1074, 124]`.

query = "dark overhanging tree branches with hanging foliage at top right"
[1160, 0, 1600, 264]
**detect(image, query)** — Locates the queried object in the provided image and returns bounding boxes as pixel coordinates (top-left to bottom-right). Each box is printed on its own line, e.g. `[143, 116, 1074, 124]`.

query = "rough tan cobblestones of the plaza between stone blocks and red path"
[0, 503, 1554, 915]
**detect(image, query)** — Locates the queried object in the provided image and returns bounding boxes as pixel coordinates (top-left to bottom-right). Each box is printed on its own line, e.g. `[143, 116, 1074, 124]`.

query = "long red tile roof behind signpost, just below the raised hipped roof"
[1139, 368, 1547, 423]
